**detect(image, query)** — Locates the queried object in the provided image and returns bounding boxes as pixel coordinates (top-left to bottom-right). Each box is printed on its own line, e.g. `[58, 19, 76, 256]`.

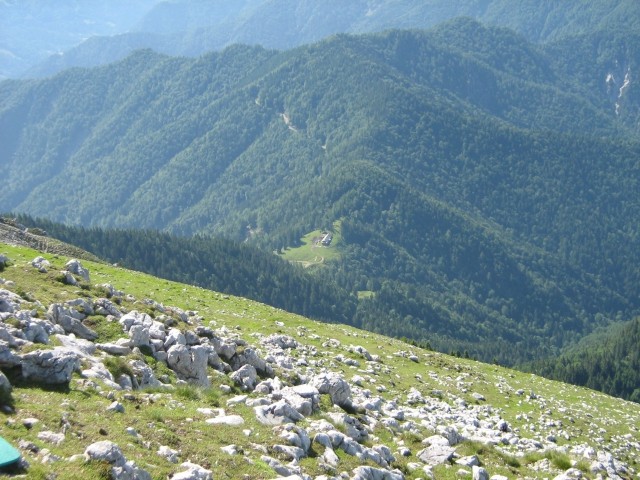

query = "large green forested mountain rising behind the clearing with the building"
[0, 19, 640, 363]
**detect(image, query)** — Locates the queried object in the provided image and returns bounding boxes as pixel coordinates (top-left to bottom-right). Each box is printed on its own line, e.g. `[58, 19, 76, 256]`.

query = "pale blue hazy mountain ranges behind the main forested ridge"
[8, 0, 640, 76]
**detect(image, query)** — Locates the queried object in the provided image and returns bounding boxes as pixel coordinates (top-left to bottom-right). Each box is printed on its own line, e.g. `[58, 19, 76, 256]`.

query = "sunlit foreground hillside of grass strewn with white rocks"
[0, 244, 640, 480]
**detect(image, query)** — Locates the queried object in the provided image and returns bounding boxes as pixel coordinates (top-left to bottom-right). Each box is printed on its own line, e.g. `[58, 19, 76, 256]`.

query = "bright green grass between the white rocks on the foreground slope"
[0, 244, 640, 479]
